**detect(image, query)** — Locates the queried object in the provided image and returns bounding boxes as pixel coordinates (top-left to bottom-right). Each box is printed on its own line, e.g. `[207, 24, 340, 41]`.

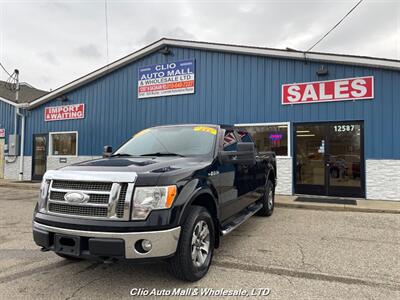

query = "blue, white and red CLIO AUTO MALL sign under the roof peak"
[138, 59, 195, 99]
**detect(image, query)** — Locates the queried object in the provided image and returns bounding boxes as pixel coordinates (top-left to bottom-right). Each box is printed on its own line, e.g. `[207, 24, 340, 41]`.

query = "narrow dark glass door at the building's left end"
[32, 134, 47, 180]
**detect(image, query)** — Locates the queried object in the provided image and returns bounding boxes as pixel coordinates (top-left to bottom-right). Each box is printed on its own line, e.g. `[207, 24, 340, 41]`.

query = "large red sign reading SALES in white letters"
[282, 76, 374, 105]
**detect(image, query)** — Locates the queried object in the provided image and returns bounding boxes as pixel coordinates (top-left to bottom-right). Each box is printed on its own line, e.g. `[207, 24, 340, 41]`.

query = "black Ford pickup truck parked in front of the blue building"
[33, 124, 276, 281]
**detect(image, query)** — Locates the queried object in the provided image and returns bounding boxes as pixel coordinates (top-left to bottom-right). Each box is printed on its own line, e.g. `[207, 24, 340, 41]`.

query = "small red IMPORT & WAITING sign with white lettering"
[44, 103, 85, 122]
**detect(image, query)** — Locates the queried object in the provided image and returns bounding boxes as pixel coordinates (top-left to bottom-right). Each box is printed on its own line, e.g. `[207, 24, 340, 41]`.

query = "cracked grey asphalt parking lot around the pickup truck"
[0, 187, 400, 299]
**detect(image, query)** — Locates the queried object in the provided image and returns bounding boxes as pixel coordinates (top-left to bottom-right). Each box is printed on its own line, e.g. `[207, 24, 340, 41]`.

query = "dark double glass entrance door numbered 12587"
[294, 122, 365, 197]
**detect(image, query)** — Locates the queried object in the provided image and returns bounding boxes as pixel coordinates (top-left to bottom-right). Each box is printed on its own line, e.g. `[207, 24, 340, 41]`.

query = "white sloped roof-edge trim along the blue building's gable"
[29, 38, 400, 109]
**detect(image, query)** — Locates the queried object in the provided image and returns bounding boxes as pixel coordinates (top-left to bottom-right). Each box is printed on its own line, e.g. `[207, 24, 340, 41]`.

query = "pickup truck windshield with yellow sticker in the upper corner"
[114, 126, 217, 156]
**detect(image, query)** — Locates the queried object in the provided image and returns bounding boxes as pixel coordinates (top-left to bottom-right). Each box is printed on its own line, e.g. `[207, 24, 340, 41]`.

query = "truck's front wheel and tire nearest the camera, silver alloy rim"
[169, 206, 215, 282]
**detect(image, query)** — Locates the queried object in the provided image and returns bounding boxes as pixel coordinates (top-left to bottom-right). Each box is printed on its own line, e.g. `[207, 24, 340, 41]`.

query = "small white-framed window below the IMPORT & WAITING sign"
[50, 132, 78, 156]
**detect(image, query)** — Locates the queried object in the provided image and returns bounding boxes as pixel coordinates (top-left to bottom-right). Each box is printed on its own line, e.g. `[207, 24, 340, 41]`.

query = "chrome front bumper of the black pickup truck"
[33, 221, 181, 259]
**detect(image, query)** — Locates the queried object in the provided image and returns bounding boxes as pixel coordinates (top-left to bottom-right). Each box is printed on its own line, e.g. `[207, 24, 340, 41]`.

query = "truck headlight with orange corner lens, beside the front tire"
[132, 185, 176, 220]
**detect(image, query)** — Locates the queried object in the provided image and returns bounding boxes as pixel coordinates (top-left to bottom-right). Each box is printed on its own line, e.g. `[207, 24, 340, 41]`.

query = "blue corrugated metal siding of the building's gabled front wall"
[26, 48, 400, 159]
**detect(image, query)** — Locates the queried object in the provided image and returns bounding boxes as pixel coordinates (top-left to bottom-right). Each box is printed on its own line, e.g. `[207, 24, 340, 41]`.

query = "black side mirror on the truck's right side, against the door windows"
[219, 142, 256, 165]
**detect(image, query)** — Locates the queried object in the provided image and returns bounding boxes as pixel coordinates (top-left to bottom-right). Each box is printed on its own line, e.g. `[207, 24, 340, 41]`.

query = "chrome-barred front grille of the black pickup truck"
[46, 179, 133, 221]
